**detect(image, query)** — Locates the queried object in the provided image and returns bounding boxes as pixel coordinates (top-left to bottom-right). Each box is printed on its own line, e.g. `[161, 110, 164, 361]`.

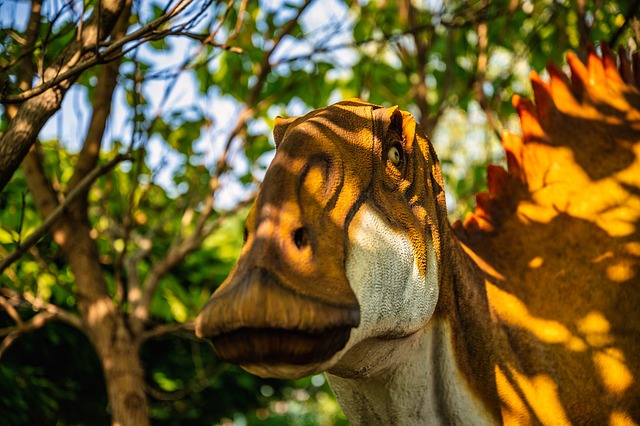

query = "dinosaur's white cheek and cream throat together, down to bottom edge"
[327, 203, 494, 425]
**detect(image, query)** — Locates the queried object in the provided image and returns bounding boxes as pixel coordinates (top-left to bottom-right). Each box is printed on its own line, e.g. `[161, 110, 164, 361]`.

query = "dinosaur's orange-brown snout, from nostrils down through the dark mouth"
[196, 194, 360, 375]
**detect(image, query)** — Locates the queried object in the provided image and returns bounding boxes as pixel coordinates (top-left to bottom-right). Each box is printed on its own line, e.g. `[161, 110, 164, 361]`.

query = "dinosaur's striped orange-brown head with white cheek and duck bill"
[196, 100, 446, 377]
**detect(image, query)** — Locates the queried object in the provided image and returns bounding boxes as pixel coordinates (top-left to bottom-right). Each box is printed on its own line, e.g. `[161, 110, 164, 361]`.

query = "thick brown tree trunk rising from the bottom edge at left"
[23, 146, 149, 426]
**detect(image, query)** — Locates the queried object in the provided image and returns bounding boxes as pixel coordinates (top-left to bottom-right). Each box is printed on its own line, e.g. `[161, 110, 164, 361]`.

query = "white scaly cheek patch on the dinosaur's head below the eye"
[346, 203, 438, 340]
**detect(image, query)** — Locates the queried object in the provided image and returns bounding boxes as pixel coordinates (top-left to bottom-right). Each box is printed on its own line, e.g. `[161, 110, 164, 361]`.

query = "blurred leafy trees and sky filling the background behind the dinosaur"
[0, 0, 640, 425]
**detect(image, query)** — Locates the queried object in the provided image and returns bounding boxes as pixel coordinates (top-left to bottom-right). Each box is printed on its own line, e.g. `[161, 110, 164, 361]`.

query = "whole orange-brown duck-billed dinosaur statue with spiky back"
[196, 45, 640, 425]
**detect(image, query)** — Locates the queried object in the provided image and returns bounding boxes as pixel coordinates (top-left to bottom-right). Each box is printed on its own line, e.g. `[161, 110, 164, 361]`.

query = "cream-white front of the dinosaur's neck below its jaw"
[327, 319, 495, 425]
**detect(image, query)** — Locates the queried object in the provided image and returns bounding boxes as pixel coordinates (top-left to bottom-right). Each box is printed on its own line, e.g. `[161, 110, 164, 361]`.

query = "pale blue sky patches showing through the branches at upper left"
[0, 0, 353, 208]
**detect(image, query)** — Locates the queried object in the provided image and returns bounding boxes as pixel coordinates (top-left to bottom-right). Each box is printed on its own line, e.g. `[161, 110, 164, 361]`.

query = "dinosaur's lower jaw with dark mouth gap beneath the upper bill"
[209, 327, 351, 378]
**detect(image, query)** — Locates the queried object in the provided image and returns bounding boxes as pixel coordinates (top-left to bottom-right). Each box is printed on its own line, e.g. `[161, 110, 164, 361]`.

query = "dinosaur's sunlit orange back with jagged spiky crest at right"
[453, 45, 640, 424]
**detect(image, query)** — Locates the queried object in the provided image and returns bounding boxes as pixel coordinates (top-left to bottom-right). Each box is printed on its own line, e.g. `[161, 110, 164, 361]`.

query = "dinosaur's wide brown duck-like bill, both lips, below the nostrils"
[196, 268, 360, 375]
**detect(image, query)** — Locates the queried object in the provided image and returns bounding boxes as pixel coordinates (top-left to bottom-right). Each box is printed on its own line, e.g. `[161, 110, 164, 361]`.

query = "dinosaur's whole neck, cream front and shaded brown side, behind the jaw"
[327, 228, 500, 425]
